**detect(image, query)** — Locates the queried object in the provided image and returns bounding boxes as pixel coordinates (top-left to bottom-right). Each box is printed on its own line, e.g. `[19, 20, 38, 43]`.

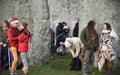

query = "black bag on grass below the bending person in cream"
[70, 57, 82, 71]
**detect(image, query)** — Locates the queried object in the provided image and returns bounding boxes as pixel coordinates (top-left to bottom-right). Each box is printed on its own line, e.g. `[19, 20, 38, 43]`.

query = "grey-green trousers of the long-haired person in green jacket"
[82, 50, 94, 73]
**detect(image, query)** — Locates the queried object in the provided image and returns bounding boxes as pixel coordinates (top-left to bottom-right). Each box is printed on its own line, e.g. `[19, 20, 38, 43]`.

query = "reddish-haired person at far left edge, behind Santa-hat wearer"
[0, 20, 10, 70]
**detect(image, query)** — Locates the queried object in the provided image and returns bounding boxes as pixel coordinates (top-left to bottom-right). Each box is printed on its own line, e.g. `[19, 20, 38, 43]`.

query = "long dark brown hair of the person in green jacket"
[87, 20, 97, 40]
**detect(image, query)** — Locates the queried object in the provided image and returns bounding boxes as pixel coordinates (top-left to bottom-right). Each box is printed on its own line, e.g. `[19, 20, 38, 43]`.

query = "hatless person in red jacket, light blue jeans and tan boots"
[18, 22, 31, 75]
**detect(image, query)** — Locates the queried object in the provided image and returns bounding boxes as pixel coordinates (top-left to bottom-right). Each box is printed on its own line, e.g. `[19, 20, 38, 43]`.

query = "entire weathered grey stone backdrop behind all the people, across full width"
[0, 0, 120, 67]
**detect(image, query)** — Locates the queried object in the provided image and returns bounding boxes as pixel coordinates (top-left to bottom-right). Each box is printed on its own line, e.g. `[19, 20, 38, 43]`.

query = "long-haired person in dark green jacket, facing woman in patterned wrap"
[80, 20, 99, 75]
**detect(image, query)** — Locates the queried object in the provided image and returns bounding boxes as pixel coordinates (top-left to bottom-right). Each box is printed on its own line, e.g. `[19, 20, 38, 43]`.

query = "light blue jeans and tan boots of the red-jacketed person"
[20, 52, 28, 73]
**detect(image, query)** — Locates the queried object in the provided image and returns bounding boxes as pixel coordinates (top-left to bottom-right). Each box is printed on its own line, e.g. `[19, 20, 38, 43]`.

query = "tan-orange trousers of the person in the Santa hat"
[10, 47, 18, 72]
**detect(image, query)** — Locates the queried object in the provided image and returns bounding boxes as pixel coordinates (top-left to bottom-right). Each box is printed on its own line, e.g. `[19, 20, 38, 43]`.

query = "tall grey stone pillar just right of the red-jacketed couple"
[30, 0, 50, 65]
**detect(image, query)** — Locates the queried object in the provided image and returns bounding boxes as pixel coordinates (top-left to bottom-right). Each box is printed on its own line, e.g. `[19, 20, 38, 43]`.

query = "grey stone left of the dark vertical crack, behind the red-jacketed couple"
[0, 0, 50, 65]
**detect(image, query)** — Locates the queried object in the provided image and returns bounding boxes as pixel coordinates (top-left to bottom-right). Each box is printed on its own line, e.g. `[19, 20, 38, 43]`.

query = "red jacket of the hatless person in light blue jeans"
[18, 29, 30, 52]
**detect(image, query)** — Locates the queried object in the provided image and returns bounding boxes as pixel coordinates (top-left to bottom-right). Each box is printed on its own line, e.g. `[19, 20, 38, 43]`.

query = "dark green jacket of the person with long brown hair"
[80, 27, 99, 50]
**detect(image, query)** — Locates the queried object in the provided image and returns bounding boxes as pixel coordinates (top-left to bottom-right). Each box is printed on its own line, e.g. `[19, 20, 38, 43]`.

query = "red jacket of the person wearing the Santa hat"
[7, 26, 19, 47]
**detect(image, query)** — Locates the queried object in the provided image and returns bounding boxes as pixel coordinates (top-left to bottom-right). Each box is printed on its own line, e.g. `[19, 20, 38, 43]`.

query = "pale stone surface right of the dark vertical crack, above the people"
[48, 0, 120, 67]
